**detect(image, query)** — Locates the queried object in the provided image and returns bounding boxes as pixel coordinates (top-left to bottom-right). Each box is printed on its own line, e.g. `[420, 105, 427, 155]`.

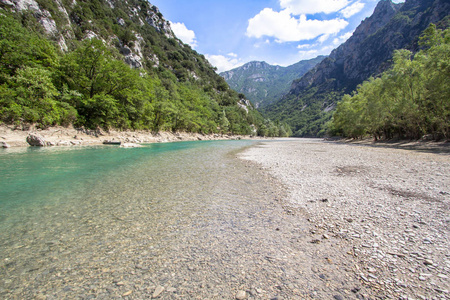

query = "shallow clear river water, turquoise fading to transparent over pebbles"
[0, 141, 304, 299]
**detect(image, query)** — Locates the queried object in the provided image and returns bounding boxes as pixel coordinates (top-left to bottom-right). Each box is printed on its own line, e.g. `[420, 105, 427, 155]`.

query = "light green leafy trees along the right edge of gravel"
[329, 24, 450, 139]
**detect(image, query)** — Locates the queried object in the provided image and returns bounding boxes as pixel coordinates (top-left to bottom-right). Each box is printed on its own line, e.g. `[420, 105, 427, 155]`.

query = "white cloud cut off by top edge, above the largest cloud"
[280, 0, 351, 15]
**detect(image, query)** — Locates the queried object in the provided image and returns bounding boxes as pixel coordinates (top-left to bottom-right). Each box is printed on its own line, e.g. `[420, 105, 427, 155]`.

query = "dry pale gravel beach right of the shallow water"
[241, 139, 450, 299]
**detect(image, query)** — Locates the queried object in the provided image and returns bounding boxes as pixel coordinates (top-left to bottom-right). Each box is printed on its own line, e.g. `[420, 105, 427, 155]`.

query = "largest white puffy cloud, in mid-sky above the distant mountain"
[246, 8, 348, 43]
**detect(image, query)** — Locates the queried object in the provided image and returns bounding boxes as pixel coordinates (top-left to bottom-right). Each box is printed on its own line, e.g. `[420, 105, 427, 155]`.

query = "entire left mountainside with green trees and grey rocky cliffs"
[0, 0, 264, 134]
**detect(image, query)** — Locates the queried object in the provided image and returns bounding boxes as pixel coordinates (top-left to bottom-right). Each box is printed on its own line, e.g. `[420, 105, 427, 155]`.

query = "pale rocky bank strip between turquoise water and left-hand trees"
[0, 125, 255, 148]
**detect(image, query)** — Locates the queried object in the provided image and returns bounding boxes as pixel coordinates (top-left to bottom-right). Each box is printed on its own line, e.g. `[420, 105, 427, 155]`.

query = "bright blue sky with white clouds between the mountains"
[150, 0, 403, 72]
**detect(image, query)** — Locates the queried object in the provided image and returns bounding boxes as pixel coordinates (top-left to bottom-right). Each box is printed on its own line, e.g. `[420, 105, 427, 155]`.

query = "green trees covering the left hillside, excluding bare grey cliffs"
[0, 11, 276, 134]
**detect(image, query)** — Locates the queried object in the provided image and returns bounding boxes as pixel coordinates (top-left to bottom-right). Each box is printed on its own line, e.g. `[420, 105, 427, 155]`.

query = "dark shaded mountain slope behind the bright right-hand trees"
[263, 0, 450, 136]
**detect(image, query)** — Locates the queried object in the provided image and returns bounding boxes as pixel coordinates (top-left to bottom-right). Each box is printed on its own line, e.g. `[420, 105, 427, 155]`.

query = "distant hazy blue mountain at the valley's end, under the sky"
[220, 56, 325, 108]
